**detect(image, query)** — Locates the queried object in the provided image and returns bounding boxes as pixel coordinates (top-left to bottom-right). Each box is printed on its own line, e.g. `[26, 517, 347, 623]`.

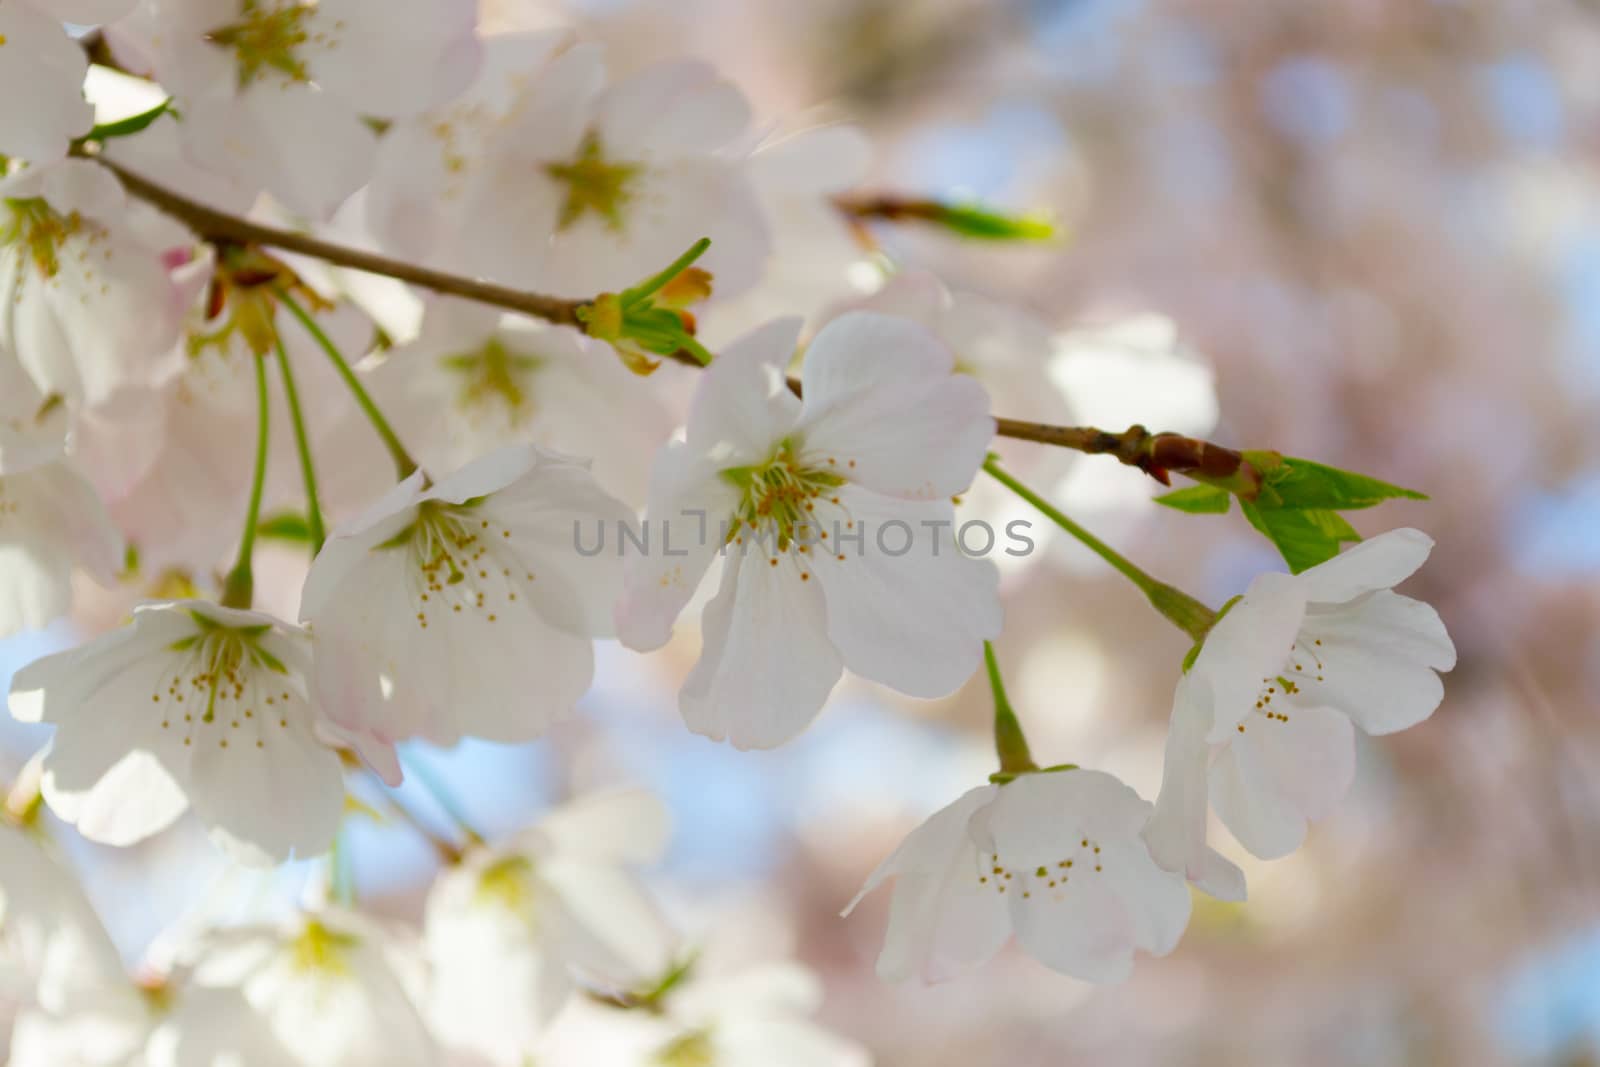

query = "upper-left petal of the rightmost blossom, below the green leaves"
[1190, 573, 1306, 744]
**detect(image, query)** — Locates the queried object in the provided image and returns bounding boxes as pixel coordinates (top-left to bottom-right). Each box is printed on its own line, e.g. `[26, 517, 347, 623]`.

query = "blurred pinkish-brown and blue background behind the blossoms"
[12, 0, 1600, 1067]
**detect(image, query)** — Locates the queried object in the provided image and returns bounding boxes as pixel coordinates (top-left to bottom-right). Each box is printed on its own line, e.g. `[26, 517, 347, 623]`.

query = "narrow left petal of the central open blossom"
[614, 442, 739, 651]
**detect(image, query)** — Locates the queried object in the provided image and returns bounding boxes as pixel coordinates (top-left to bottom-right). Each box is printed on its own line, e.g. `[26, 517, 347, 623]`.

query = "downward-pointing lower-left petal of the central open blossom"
[678, 550, 843, 749]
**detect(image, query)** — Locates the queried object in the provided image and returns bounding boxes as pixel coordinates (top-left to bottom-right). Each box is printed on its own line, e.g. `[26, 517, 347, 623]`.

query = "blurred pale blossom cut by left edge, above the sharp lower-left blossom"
[0, 396, 123, 637]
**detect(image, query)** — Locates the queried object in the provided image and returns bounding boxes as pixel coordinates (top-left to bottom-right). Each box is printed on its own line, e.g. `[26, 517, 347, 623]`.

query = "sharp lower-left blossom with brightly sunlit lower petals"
[11, 600, 344, 865]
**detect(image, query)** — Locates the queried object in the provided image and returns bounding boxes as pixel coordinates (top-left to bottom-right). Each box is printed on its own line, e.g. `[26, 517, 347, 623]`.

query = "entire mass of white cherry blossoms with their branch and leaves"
[0, 0, 1454, 1065]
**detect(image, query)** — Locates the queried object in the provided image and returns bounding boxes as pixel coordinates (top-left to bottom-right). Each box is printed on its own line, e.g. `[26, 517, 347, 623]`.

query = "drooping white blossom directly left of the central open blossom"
[301, 445, 632, 784]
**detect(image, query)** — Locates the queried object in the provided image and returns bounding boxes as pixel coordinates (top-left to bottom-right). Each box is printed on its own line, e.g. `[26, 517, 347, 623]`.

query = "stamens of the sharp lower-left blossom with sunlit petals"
[150, 614, 298, 749]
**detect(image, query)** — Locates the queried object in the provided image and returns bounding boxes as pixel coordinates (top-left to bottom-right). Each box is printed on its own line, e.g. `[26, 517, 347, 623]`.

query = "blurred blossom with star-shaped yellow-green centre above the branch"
[461, 45, 768, 298]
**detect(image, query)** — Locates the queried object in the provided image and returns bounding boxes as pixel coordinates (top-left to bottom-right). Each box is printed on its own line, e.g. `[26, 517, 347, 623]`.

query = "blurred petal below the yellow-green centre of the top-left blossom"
[181, 83, 378, 221]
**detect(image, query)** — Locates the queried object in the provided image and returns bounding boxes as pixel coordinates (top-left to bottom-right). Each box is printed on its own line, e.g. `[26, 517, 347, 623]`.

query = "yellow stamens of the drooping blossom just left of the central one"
[398, 501, 534, 630]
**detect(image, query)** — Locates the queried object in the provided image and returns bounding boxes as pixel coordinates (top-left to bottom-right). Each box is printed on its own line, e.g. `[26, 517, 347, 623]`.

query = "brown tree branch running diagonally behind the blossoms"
[109, 157, 1261, 499]
